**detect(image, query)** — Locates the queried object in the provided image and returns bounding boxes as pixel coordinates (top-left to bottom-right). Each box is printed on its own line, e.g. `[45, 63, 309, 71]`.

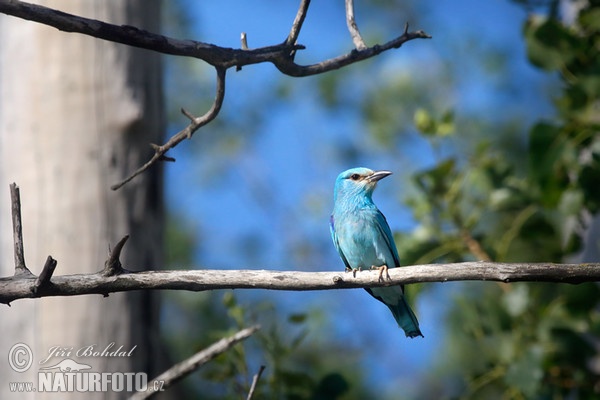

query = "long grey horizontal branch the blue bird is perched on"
[0, 262, 600, 304]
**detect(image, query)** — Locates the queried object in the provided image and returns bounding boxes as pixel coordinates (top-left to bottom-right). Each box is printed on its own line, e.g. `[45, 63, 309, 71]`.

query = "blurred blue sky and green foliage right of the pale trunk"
[162, 0, 600, 399]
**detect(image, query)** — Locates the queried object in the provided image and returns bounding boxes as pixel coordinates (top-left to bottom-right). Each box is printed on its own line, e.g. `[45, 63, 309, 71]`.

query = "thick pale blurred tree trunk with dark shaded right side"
[0, 0, 164, 399]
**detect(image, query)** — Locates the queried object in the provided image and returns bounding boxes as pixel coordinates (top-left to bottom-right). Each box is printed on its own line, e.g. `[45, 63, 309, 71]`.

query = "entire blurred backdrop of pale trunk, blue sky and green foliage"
[0, 0, 600, 400]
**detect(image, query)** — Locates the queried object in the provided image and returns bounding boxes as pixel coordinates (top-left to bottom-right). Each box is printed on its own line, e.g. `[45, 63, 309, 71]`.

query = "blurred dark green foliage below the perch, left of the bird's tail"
[199, 292, 372, 400]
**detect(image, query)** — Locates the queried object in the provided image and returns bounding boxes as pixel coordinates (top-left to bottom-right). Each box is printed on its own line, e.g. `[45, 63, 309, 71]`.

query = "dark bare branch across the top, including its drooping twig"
[0, 0, 431, 190]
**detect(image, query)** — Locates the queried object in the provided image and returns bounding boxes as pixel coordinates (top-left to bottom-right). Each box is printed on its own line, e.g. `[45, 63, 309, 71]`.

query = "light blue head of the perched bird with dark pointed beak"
[334, 168, 392, 203]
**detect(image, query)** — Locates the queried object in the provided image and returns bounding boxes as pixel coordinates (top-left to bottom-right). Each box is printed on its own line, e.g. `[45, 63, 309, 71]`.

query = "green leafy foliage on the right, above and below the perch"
[399, 2, 600, 399]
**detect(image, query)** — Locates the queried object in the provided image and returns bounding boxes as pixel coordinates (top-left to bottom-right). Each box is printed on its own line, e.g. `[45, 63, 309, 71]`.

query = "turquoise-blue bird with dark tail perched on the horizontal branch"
[330, 168, 423, 338]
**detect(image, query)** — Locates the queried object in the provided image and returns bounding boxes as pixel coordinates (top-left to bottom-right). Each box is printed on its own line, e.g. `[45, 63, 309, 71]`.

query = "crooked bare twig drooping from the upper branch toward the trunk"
[110, 67, 226, 190]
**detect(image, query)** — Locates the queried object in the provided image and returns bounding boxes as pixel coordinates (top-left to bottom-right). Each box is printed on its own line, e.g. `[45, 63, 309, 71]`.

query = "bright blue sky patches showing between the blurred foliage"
[166, 0, 553, 394]
